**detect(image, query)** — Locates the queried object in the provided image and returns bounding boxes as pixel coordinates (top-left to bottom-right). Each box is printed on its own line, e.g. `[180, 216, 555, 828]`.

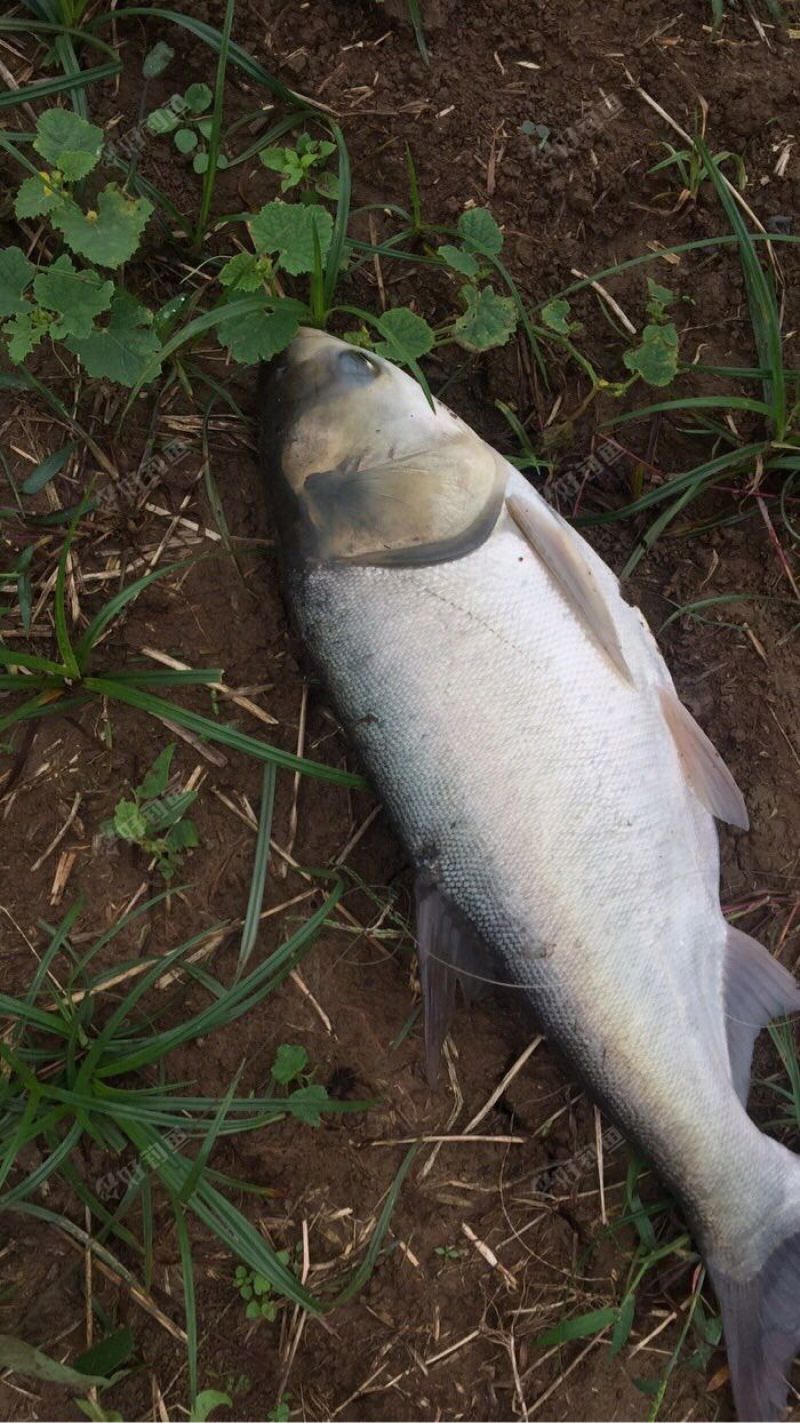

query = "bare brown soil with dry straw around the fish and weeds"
[0, 0, 800, 1420]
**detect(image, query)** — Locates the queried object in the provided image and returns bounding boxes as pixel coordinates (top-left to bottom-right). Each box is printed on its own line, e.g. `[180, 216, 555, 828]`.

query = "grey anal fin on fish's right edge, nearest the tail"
[725, 925, 800, 1103]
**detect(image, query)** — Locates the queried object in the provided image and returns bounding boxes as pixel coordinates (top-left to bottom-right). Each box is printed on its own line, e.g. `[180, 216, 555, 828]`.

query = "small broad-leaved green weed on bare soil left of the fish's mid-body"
[102, 741, 199, 879]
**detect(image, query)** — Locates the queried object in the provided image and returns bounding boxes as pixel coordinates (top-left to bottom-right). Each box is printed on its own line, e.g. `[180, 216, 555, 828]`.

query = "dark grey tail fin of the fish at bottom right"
[709, 1189, 800, 1423]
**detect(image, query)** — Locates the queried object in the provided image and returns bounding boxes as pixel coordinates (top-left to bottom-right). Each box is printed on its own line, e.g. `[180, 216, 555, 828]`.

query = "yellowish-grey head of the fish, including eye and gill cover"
[259, 329, 507, 565]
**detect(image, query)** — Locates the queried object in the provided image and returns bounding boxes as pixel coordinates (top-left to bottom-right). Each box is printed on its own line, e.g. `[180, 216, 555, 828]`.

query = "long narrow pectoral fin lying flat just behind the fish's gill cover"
[505, 494, 633, 683]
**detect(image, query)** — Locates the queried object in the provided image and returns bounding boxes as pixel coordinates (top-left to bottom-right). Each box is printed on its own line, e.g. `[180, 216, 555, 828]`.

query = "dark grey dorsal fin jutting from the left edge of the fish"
[416, 872, 491, 1086]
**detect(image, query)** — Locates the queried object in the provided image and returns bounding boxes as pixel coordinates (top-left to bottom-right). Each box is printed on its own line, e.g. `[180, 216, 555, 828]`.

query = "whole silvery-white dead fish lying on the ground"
[259, 329, 800, 1420]
